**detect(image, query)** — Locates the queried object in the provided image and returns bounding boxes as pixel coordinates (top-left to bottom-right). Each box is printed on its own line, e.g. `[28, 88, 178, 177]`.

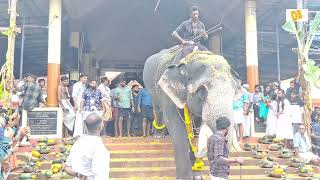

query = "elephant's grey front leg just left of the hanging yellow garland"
[163, 103, 193, 179]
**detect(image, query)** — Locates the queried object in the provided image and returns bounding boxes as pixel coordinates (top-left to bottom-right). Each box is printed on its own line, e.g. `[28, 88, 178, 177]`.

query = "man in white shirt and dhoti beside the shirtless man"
[72, 74, 88, 137]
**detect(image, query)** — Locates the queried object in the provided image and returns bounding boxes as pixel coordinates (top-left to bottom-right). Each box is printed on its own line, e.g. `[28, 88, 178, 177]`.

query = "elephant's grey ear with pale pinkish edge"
[158, 64, 187, 109]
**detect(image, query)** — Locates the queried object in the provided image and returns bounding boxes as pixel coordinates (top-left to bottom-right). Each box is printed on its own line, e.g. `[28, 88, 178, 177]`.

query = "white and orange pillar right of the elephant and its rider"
[245, 0, 259, 92]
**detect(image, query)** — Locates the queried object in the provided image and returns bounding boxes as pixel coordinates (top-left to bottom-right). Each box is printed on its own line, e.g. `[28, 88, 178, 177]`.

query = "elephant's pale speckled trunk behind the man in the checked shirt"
[202, 81, 241, 151]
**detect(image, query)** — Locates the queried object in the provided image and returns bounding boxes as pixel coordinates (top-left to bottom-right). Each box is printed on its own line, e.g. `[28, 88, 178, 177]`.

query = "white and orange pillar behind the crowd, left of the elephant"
[48, 0, 61, 107]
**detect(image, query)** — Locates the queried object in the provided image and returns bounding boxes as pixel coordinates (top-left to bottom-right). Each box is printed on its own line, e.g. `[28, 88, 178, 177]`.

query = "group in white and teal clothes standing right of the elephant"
[233, 80, 304, 147]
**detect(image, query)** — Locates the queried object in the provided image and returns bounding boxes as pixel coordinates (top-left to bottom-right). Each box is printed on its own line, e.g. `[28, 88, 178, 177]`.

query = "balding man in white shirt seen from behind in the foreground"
[65, 113, 110, 180]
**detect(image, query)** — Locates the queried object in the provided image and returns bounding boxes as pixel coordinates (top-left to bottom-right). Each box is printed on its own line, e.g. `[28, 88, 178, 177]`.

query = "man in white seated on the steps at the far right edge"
[293, 124, 320, 165]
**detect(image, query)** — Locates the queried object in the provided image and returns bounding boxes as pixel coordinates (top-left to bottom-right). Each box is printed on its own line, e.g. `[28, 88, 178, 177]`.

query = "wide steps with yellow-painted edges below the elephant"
[9, 137, 305, 180]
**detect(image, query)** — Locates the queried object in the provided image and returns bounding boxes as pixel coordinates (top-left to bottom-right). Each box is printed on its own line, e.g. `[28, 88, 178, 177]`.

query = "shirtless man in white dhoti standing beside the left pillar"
[58, 76, 76, 136]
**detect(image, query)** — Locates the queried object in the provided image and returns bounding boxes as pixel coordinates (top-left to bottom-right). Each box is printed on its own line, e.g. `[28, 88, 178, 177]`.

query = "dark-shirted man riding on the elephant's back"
[172, 6, 208, 59]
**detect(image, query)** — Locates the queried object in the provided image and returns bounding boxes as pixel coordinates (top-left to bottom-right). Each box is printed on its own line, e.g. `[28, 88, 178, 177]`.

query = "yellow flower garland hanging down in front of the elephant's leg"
[183, 105, 204, 171]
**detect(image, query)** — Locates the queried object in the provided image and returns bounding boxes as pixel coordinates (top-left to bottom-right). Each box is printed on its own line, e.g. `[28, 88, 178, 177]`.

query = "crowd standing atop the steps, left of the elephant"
[1, 74, 154, 137]
